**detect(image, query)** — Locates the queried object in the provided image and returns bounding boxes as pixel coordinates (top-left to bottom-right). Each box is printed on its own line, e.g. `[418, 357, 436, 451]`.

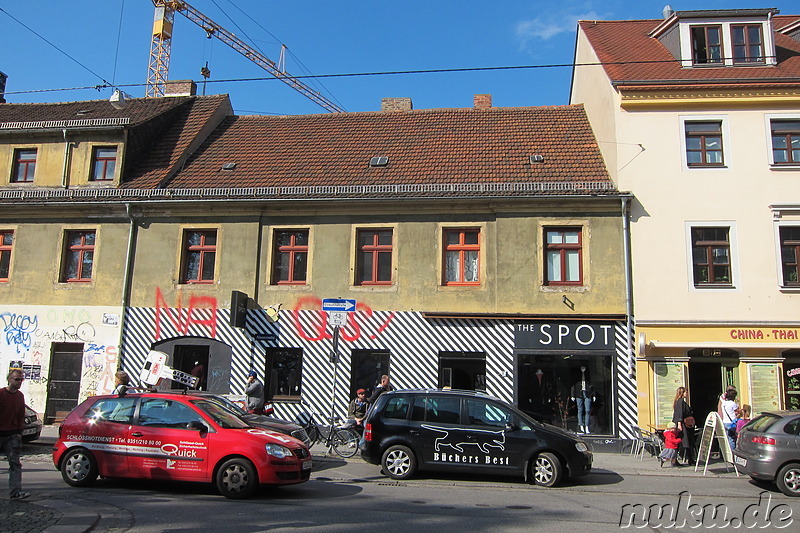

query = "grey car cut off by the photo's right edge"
[733, 411, 800, 496]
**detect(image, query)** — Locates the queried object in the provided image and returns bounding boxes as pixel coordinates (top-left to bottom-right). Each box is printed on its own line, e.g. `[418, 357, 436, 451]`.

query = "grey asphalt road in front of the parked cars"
[7, 444, 800, 533]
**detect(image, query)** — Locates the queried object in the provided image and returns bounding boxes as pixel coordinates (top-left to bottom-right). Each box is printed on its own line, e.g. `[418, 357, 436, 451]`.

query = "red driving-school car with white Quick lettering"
[53, 392, 311, 498]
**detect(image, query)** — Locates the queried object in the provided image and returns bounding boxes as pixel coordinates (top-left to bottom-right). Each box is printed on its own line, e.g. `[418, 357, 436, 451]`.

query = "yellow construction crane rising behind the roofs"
[145, 0, 344, 113]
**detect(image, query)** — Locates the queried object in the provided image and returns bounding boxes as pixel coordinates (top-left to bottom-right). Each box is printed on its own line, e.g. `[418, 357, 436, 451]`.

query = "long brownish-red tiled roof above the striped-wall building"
[168, 105, 611, 189]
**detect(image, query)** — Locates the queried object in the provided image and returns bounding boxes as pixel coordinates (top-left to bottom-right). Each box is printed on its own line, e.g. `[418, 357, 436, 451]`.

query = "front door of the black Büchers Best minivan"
[464, 398, 530, 473]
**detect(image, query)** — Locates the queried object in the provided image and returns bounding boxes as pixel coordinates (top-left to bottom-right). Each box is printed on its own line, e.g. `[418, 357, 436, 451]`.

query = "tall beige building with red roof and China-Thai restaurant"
[571, 10, 800, 429]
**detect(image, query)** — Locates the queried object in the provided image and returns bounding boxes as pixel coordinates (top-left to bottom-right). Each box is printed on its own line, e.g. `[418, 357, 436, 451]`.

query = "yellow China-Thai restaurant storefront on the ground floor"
[636, 324, 800, 428]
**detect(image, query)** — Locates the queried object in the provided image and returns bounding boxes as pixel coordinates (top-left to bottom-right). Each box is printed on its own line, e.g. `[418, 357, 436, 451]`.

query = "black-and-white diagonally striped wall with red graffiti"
[123, 307, 637, 438]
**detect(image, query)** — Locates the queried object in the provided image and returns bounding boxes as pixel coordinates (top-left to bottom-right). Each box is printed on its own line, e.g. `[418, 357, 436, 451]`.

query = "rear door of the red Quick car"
[76, 398, 136, 477]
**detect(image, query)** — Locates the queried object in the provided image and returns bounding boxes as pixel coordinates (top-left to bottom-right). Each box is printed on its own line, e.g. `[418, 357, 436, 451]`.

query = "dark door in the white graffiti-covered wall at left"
[44, 342, 83, 424]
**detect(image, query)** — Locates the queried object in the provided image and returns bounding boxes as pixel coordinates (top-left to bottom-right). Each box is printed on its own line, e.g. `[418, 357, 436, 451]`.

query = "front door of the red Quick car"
[128, 398, 209, 481]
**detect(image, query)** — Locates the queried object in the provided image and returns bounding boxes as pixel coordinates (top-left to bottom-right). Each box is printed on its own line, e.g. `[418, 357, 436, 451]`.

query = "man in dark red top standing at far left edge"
[0, 368, 31, 500]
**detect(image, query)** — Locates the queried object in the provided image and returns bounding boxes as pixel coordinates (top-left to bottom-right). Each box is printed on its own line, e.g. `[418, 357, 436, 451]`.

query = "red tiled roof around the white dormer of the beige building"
[576, 15, 800, 87]
